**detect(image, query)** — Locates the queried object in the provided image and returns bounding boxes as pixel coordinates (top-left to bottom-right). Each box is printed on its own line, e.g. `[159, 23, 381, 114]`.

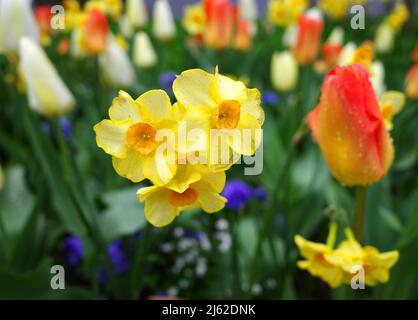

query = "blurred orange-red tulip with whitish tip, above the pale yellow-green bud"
[293, 8, 324, 65]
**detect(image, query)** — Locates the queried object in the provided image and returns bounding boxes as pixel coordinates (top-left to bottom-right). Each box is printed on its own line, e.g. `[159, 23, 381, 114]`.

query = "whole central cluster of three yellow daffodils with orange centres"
[94, 69, 264, 227]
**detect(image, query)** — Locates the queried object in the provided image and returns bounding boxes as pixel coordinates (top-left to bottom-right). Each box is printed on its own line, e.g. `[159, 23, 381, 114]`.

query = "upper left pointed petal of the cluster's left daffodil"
[109, 90, 141, 122]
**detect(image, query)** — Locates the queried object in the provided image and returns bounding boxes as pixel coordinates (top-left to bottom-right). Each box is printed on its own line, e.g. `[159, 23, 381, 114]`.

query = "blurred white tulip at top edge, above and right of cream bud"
[152, 0, 176, 41]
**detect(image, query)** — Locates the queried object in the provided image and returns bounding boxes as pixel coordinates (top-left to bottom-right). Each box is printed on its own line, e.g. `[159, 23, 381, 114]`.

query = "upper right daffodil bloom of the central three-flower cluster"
[173, 69, 264, 164]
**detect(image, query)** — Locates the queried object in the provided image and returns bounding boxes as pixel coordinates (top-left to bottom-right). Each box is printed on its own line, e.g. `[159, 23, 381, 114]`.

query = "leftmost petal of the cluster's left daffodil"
[93, 120, 132, 158]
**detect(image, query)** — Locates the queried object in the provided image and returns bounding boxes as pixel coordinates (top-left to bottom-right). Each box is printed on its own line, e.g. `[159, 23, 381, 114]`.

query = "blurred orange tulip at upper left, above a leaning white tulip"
[83, 9, 109, 54]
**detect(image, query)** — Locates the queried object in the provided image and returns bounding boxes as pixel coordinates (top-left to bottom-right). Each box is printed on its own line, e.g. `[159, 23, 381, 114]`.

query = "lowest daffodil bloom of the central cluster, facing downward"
[138, 164, 226, 227]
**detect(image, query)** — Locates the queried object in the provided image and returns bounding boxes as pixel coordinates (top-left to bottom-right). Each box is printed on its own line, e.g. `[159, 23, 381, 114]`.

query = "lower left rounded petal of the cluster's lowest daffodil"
[139, 188, 179, 227]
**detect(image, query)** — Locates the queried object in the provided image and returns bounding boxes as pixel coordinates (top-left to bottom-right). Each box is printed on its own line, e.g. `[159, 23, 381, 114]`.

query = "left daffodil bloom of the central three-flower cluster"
[94, 90, 178, 185]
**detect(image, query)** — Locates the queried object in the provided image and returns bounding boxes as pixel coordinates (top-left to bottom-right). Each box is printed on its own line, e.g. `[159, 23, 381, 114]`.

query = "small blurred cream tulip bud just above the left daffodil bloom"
[133, 31, 158, 68]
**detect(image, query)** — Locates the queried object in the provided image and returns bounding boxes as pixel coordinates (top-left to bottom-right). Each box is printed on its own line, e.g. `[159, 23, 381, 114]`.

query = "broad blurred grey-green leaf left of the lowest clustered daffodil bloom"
[99, 187, 146, 242]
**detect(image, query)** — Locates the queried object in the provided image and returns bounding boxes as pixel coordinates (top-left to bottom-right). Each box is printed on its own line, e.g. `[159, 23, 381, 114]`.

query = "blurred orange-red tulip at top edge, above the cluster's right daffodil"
[204, 0, 236, 49]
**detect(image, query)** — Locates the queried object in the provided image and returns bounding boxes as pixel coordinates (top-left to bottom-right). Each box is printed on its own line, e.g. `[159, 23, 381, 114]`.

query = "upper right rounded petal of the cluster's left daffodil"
[135, 90, 173, 123]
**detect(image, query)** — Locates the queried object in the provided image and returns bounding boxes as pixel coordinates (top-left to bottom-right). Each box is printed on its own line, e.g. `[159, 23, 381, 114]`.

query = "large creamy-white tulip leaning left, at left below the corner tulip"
[19, 37, 75, 117]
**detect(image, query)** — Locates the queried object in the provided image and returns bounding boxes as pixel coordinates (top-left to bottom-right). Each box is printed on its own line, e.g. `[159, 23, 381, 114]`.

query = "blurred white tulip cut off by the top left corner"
[0, 0, 39, 53]
